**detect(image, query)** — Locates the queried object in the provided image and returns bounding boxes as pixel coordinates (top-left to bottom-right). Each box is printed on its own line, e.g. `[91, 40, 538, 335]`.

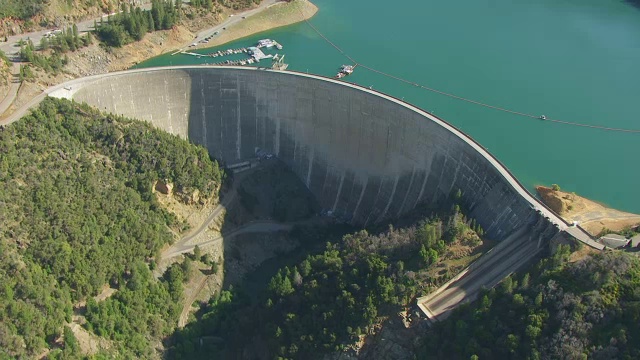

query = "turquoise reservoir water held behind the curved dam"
[138, 0, 640, 213]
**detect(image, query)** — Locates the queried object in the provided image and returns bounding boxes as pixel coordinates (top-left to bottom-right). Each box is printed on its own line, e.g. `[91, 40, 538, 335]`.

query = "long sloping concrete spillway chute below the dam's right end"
[418, 229, 542, 321]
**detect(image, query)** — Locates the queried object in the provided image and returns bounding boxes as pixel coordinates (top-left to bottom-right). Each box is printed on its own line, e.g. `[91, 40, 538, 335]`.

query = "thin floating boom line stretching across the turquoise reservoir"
[300, 11, 640, 134]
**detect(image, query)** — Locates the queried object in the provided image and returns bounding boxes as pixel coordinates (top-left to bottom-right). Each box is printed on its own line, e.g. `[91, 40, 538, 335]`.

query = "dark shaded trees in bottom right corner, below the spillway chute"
[423, 247, 640, 359]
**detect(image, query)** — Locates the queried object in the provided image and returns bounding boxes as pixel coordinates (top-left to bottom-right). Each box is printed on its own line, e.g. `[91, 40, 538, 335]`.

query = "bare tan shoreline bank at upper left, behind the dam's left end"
[0, 0, 318, 123]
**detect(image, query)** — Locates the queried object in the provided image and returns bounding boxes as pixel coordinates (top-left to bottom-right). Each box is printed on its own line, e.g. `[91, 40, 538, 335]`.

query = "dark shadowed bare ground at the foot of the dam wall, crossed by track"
[216, 158, 323, 290]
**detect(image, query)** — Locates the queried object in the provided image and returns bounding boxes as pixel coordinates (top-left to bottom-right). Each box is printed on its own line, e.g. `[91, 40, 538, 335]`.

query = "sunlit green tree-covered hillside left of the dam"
[0, 98, 222, 358]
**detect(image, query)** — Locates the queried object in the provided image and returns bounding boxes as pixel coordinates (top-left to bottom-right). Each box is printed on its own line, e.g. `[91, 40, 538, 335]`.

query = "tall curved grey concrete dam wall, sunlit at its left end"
[60, 67, 562, 240]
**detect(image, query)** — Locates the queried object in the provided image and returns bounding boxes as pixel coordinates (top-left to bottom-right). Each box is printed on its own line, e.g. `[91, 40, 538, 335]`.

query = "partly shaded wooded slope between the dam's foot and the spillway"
[170, 204, 480, 359]
